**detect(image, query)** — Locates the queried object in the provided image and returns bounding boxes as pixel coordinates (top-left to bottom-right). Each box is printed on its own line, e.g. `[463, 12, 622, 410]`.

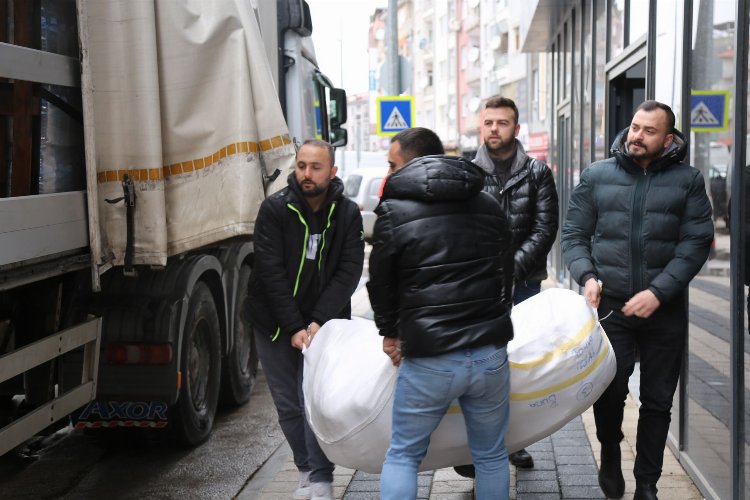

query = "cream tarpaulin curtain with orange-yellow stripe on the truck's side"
[78, 0, 294, 265]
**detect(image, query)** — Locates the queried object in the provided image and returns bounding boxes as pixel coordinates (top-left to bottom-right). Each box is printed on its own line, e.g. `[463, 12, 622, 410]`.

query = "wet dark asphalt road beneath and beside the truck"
[0, 371, 284, 500]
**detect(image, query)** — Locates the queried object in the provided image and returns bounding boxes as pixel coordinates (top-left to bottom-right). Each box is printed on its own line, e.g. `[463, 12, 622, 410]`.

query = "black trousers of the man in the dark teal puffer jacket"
[594, 297, 688, 484]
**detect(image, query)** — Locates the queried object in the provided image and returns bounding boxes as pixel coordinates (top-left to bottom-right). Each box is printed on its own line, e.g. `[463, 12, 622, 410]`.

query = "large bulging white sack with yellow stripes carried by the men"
[303, 289, 616, 473]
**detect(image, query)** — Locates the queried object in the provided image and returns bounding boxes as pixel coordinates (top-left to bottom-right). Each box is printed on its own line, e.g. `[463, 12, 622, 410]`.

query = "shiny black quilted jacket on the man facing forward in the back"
[474, 141, 560, 281]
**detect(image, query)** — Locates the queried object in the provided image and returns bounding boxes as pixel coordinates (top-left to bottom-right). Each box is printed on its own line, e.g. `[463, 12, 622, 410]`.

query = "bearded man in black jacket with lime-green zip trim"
[248, 139, 364, 500]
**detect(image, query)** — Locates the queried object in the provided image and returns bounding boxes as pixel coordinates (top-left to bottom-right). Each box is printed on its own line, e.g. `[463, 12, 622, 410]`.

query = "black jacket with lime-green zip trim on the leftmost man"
[249, 173, 365, 338]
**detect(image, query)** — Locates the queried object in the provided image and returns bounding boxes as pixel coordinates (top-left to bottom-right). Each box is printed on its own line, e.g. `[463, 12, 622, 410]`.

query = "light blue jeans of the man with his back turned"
[380, 345, 510, 500]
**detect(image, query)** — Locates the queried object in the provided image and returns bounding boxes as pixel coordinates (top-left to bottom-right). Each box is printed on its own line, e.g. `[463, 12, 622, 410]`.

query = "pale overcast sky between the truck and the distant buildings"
[307, 0, 388, 95]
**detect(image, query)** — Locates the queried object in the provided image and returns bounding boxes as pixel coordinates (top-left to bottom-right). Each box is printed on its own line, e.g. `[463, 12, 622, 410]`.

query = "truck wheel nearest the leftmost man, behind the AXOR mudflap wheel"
[221, 266, 258, 406]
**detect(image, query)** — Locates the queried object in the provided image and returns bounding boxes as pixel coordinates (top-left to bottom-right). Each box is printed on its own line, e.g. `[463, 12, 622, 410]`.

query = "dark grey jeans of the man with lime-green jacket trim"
[255, 328, 334, 483]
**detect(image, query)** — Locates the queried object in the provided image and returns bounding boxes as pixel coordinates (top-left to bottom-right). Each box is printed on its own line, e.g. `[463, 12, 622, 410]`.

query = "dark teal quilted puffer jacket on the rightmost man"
[561, 129, 714, 304]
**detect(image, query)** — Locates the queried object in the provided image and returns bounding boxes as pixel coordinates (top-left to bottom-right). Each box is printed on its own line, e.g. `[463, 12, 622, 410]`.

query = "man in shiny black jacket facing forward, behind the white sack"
[476, 96, 560, 472]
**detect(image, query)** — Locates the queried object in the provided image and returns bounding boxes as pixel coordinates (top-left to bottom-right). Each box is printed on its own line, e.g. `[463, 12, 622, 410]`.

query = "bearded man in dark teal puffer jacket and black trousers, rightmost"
[561, 101, 714, 500]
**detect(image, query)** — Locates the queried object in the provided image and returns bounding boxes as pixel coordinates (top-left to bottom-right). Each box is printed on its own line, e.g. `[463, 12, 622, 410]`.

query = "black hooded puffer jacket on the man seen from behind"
[367, 156, 513, 357]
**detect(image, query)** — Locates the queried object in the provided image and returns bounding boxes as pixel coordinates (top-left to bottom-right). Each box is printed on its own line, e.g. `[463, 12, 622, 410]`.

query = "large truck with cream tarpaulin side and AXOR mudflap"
[0, 0, 347, 455]
